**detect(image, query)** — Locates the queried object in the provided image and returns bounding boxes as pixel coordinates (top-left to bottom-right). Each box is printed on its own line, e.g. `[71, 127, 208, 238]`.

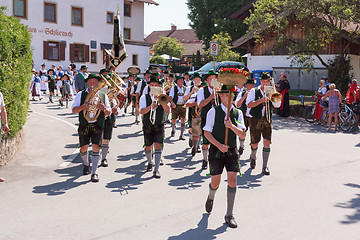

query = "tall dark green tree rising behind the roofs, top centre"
[187, 0, 250, 46]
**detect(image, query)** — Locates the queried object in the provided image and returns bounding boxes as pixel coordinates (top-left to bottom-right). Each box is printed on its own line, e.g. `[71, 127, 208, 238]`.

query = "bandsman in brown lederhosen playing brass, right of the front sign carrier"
[246, 72, 281, 175]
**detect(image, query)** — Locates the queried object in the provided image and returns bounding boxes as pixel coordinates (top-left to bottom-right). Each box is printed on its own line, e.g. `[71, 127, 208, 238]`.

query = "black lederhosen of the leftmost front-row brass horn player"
[78, 122, 103, 147]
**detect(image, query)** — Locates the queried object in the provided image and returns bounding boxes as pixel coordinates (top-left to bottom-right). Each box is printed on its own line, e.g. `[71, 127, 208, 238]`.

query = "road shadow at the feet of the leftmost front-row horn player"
[33, 159, 90, 196]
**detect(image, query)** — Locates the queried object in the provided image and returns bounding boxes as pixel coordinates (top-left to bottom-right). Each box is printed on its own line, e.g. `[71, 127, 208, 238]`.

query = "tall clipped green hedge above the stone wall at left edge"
[0, 7, 32, 137]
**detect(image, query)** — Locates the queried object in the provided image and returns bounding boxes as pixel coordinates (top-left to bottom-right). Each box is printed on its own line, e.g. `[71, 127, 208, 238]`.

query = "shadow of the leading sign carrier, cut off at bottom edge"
[168, 213, 227, 240]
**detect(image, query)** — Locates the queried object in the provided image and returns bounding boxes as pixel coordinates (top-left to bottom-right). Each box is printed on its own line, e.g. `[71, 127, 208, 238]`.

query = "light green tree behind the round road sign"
[206, 32, 241, 62]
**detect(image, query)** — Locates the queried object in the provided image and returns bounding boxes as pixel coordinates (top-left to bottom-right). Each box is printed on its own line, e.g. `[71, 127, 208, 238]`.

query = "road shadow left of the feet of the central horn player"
[106, 162, 152, 195]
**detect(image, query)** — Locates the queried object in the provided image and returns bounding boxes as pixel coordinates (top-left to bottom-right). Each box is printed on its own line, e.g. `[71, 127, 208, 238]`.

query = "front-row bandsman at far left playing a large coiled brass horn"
[72, 74, 111, 182]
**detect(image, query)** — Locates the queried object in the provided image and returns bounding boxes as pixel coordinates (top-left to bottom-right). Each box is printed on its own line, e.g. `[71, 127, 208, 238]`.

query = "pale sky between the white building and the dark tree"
[144, 0, 190, 35]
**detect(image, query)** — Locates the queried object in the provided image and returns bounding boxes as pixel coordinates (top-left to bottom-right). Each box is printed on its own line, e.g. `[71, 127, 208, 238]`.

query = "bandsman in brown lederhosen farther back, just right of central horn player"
[169, 76, 186, 140]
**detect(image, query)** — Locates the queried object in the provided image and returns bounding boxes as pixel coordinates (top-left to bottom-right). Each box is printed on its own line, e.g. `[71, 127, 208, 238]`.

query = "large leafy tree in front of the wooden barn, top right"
[246, 0, 360, 86]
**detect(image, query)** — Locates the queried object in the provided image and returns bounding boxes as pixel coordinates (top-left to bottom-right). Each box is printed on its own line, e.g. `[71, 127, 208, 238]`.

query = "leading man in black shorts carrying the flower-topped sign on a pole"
[203, 85, 245, 228]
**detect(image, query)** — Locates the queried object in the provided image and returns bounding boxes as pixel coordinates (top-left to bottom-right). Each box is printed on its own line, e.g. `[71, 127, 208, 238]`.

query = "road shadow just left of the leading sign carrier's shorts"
[169, 169, 210, 190]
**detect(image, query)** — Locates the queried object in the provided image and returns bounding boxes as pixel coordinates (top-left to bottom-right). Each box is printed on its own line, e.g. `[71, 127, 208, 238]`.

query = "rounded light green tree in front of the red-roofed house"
[152, 37, 185, 58]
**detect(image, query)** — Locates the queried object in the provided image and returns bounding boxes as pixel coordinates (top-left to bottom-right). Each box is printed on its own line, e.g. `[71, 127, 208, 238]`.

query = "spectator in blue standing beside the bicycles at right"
[322, 83, 342, 131]
